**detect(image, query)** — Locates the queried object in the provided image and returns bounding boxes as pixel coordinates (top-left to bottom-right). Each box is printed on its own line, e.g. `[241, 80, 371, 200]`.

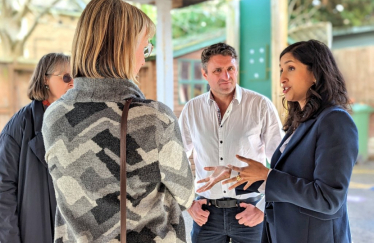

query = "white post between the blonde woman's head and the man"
[156, 0, 174, 110]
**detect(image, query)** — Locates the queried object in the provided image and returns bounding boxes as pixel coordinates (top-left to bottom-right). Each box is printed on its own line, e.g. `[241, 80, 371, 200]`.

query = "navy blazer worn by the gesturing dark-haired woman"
[238, 107, 358, 243]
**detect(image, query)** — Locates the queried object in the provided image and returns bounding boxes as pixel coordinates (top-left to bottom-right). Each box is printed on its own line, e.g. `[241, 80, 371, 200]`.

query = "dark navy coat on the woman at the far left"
[0, 101, 56, 243]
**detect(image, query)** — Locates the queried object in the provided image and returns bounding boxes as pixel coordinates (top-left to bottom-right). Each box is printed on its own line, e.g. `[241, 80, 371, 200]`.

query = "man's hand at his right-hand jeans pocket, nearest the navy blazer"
[235, 203, 264, 227]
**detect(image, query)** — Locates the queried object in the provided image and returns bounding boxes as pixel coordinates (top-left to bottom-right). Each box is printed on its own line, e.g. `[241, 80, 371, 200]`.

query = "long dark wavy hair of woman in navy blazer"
[279, 40, 349, 132]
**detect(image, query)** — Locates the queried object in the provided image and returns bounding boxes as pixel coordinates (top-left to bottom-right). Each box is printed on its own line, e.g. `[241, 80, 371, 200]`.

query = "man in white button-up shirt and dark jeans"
[179, 43, 283, 243]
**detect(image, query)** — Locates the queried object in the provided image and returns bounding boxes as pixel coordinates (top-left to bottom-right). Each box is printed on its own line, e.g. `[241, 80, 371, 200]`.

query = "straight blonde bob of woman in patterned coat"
[71, 0, 155, 81]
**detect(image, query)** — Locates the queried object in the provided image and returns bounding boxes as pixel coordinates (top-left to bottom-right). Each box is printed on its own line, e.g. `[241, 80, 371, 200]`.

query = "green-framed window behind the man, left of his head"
[178, 59, 209, 104]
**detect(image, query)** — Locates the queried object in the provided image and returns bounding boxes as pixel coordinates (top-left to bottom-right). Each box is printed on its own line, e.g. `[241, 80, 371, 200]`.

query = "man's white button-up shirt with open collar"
[179, 85, 283, 207]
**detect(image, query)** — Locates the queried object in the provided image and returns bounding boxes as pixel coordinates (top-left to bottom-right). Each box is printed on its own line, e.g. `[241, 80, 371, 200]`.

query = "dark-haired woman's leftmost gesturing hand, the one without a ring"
[196, 166, 231, 193]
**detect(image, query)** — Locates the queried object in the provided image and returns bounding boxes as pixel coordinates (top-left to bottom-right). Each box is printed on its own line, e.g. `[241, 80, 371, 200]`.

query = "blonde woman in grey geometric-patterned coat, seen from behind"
[43, 0, 194, 243]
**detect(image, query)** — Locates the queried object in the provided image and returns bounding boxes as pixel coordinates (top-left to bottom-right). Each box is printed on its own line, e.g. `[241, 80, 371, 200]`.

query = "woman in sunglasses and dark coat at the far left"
[0, 53, 73, 243]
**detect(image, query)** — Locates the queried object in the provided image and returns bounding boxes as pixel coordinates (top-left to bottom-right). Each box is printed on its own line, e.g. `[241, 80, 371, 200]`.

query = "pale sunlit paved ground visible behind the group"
[183, 161, 374, 243]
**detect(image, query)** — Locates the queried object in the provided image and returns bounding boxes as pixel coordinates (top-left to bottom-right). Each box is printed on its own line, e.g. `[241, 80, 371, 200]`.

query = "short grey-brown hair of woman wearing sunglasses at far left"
[27, 53, 70, 101]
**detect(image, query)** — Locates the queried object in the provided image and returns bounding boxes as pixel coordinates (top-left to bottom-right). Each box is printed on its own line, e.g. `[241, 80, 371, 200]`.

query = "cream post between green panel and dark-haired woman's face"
[271, 0, 288, 122]
